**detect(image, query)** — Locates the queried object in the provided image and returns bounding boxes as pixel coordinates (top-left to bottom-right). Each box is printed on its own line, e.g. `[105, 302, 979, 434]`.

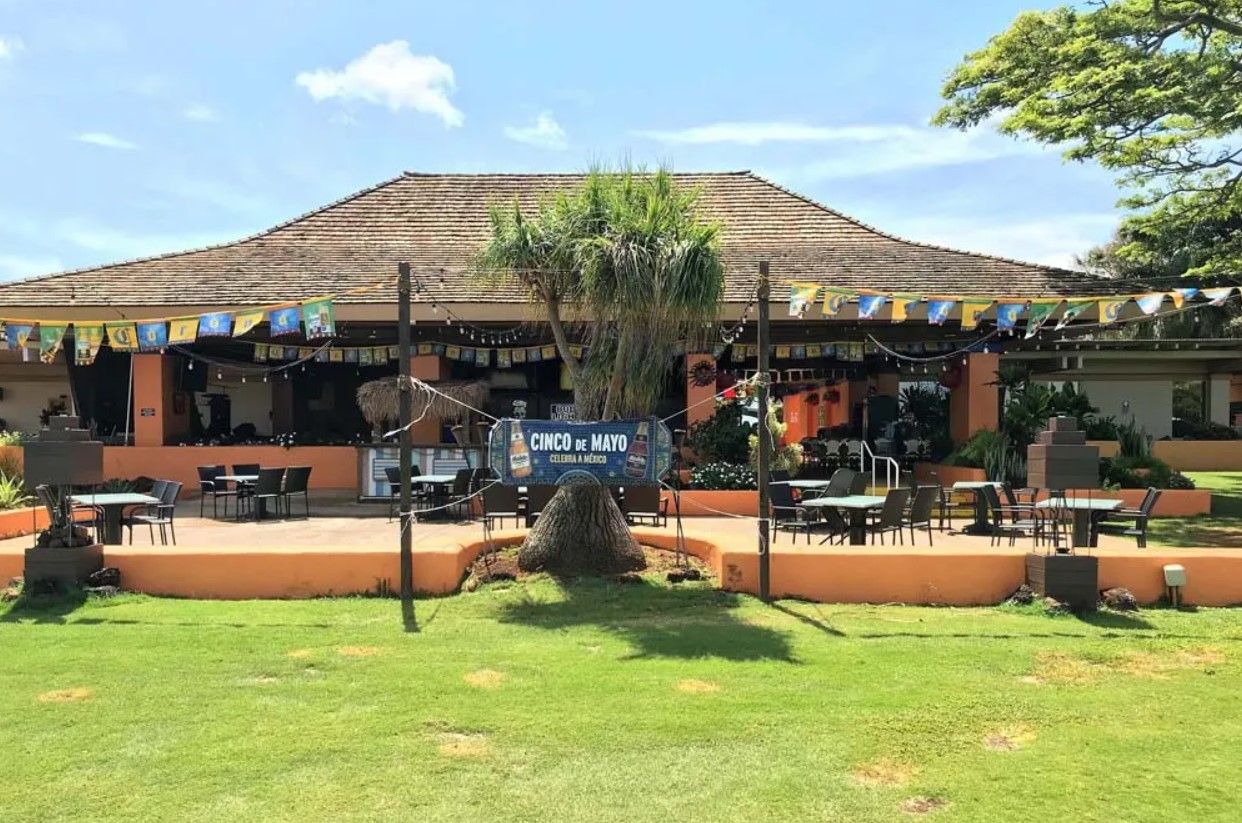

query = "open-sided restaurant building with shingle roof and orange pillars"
[0, 171, 1242, 495]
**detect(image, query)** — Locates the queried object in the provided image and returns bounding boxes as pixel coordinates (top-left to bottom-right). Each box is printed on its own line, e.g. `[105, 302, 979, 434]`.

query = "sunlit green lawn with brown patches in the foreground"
[0, 580, 1242, 823]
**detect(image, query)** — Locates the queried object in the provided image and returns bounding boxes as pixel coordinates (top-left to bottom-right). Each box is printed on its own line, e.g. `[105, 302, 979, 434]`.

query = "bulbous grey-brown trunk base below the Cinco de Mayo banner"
[518, 484, 647, 575]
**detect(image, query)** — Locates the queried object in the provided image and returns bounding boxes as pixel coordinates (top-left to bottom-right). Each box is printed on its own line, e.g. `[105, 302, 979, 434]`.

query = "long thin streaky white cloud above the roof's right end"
[633, 116, 1049, 177]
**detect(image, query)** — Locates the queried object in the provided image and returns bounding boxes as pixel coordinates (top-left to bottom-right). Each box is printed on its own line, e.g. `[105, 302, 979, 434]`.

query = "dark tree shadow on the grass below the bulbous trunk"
[498, 578, 802, 663]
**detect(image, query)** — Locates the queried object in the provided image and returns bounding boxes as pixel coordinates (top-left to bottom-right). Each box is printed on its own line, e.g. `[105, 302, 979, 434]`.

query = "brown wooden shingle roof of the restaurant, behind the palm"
[0, 171, 1108, 310]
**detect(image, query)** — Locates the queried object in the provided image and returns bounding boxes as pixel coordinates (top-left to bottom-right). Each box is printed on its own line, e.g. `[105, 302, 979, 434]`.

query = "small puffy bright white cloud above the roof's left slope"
[296, 40, 466, 127]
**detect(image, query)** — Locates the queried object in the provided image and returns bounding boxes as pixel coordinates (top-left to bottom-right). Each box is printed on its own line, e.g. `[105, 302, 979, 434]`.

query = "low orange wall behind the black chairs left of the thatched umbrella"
[103, 446, 358, 494]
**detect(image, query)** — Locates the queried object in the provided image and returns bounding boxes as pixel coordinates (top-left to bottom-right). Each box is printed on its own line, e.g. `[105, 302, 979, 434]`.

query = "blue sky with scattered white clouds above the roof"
[0, 0, 1119, 278]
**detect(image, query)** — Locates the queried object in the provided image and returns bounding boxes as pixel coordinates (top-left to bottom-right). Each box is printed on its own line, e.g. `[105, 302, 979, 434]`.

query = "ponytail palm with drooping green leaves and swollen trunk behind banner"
[476, 169, 724, 573]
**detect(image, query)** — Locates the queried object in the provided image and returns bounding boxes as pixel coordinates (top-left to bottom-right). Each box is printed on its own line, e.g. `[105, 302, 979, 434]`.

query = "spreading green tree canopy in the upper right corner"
[935, 0, 1242, 274]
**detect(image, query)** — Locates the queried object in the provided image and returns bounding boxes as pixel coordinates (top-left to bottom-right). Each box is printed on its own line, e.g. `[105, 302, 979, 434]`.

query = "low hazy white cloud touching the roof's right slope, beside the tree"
[881, 212, 1120, 268]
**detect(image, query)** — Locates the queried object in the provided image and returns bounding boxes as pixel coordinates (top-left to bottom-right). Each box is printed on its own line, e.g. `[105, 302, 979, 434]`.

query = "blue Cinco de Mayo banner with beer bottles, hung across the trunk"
[488, 417, 673, 485]
